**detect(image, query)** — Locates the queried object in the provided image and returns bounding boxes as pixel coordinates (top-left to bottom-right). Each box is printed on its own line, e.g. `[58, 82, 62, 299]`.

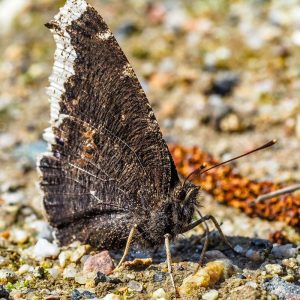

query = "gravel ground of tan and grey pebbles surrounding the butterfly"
[0, 0, 300, 300]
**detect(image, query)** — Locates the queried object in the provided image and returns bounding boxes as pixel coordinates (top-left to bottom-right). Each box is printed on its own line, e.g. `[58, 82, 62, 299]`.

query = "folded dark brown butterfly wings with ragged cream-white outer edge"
[38, 0, 178, 248]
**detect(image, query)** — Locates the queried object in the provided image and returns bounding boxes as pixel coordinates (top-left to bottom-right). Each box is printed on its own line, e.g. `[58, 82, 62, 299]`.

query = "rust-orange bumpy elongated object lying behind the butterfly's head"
[169, 145, 300, 229]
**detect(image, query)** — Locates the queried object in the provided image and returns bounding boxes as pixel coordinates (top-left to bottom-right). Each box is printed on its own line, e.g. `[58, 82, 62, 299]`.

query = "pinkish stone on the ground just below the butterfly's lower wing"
[83, 251, 114, 275]
